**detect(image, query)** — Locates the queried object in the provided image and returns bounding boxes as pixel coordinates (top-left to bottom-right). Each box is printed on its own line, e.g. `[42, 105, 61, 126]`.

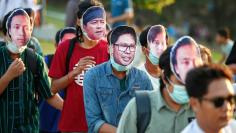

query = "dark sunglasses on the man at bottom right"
[200, 95, 236, 108]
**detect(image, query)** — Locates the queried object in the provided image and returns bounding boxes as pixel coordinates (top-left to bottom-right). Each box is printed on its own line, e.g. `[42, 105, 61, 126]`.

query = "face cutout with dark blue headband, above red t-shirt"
[80, 6, 106, 40]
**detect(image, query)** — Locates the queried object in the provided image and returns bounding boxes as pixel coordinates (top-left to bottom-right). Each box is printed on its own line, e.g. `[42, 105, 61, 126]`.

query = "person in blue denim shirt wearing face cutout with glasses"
[84, 26, 152, 133]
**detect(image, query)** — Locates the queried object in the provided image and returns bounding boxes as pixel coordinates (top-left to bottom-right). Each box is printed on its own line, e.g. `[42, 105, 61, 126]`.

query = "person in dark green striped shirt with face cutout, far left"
[0, 8, 63, 133]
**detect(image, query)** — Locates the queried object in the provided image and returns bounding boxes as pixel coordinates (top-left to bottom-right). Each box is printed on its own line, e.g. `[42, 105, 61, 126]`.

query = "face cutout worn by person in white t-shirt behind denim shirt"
[147, 25, 167, 65]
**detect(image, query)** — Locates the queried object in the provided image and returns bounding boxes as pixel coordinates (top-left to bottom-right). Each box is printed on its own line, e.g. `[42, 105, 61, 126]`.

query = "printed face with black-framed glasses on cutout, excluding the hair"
[113, 34, 136, 66]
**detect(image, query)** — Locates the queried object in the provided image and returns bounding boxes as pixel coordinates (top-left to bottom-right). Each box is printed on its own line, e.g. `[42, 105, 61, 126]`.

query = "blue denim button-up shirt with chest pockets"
[84, 61, 153, 133]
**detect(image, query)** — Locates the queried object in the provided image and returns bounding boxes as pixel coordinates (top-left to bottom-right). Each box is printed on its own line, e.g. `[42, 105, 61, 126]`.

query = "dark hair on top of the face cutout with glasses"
[107, 26, 137, 45]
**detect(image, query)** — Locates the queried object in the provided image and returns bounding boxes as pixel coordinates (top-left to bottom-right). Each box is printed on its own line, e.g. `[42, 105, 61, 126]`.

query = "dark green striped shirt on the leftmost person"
[0, 46, 52, 133]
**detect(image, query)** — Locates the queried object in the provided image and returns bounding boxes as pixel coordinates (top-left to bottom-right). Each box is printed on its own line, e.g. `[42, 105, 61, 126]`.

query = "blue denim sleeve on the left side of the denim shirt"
[83, 68, 105, 133]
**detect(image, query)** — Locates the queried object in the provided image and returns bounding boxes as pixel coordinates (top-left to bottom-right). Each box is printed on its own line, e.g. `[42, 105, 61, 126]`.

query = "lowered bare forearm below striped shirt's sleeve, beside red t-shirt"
[47, 93, 63, 111]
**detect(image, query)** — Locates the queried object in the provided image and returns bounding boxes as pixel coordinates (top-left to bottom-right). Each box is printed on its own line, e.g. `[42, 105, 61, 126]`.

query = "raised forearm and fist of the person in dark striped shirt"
[0, 58, 25, 95]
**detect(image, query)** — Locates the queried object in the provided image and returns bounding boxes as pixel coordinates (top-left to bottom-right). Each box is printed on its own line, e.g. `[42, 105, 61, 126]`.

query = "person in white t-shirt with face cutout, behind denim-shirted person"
[139, 25, 168, 90]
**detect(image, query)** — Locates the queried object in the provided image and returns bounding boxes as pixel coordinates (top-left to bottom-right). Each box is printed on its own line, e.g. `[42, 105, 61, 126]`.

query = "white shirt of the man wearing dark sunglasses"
[181, 119, 236, 133]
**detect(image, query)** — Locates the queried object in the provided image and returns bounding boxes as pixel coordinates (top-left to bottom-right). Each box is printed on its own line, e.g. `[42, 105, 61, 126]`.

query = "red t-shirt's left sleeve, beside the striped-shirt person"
[48, 41, 69, 78]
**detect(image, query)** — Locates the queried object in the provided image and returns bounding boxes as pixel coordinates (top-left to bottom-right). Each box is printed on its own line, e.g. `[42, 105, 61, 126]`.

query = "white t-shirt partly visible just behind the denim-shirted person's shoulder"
[138, 65, 160, 90]
